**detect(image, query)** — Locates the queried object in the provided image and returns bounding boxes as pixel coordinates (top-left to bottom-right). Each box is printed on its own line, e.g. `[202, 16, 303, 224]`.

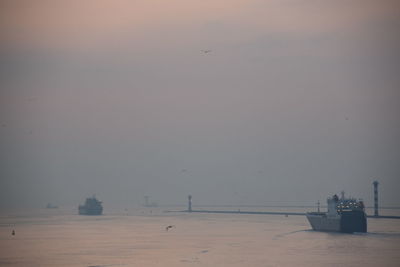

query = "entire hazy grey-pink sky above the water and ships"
[0, 0, 400, 213]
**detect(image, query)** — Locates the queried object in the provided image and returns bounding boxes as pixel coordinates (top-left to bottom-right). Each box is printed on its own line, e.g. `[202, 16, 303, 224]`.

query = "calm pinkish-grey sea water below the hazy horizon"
[0, 208, 400, 267]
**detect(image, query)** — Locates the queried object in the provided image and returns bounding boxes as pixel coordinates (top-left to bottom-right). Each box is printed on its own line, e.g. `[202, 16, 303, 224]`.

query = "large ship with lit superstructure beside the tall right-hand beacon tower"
[307, 194, 367, 233]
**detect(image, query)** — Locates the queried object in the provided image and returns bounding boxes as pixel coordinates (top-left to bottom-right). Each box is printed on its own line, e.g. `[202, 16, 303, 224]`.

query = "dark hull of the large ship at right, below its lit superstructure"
[307, 211, 367, 233]
